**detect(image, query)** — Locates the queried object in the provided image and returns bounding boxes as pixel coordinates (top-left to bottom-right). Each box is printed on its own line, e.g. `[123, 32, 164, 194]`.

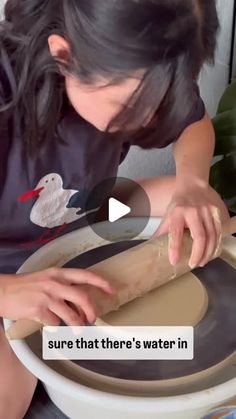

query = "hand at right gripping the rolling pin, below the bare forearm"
[155, 185, 221, 269]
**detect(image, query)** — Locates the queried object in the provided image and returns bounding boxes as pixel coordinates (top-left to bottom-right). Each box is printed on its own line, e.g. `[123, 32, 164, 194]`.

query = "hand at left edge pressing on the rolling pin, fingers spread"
[0, 268, 114, 326]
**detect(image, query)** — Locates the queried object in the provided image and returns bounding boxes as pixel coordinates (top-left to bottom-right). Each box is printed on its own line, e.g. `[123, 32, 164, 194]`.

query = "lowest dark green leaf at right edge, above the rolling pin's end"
[210, 153, 236, 199]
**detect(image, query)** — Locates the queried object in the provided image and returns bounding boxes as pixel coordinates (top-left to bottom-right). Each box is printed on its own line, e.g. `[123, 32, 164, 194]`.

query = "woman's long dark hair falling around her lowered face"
[0, 0, 219, 150]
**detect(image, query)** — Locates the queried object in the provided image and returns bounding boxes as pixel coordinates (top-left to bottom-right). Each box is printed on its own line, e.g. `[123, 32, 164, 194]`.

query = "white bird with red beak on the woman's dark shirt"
[18, 173, 98, 229]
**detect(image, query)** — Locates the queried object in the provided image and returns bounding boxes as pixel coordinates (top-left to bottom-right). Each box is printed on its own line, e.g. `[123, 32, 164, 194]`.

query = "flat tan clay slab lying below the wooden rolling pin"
[97, 273, 208, 326]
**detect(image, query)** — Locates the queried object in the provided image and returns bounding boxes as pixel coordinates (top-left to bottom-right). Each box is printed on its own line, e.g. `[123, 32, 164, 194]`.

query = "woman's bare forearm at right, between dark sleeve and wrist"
[174, 114, 215, 186]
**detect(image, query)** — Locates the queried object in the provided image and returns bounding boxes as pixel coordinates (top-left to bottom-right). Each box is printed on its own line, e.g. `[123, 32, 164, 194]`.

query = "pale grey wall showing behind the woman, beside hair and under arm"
[120, 0, 233, 179]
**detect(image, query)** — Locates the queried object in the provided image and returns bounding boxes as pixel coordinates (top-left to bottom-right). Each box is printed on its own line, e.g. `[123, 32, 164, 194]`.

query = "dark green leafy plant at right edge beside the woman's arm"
[210, 79, 236, 215]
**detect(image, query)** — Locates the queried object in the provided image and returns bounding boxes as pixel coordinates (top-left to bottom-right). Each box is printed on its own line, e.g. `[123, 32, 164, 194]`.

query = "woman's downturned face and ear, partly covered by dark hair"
[48, 35, 153, 131]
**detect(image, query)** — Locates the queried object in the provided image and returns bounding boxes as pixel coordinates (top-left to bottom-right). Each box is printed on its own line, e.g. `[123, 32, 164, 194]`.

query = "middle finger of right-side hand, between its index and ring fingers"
[186, 211, 206, 269]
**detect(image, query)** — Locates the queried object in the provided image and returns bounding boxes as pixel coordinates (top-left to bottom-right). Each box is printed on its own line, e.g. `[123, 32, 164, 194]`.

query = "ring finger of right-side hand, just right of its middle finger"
[199, 207, 217, 267]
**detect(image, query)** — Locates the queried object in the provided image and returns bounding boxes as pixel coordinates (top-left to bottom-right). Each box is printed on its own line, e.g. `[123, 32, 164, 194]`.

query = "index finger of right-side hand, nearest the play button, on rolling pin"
[169, 215, 185, 266]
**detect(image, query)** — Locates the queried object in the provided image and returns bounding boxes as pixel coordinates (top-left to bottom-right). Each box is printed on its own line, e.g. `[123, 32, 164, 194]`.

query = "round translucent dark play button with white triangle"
[86, 177, 151, 242]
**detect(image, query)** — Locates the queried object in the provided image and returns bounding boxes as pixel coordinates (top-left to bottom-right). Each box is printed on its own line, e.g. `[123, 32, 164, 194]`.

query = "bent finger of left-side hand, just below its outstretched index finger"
[50, 284, 97, 323]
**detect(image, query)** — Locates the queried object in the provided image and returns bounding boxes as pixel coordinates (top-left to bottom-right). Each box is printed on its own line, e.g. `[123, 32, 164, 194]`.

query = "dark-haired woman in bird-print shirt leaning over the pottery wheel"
[0, 0, 228, 418]
